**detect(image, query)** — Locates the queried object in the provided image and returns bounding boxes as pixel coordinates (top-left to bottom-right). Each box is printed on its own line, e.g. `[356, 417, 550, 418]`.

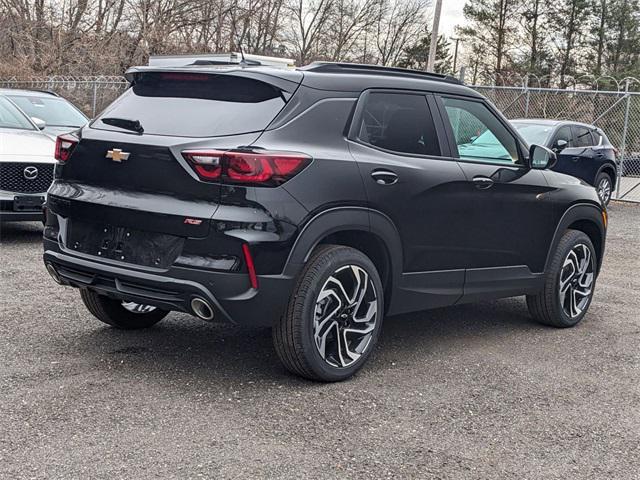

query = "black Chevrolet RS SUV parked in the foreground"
[44, 63, 606, 381]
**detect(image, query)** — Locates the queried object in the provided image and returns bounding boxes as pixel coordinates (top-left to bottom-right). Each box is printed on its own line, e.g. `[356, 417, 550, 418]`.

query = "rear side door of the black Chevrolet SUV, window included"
[349, 90, 465, 313]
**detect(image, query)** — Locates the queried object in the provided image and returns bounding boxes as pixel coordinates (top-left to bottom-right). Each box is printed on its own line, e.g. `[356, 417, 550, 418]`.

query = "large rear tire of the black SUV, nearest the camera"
[272, 245, 384, 382]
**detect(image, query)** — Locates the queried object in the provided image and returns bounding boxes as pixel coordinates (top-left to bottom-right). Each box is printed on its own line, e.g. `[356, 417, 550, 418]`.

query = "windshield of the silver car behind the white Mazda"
[7, 95, 87, 127]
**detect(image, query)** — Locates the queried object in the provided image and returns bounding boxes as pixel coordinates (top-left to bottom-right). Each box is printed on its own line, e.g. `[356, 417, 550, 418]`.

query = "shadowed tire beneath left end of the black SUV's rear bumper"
[80, 288, 169, 330]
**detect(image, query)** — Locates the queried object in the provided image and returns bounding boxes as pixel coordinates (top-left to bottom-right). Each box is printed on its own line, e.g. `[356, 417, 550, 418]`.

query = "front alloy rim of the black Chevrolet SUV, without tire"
[558, 243, 595, 318]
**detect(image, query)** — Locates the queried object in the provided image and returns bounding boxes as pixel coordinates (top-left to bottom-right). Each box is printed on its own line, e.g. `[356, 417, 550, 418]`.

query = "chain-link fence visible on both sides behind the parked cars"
[0, 76, 640, 202]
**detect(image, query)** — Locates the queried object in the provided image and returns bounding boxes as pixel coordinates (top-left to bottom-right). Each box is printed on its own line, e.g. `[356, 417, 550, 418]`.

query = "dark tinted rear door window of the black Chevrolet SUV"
[358, 93, 440, 155]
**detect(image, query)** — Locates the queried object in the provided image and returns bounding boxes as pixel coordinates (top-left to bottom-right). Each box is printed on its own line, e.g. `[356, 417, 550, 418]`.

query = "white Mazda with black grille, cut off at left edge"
[0, 95, 56, 222]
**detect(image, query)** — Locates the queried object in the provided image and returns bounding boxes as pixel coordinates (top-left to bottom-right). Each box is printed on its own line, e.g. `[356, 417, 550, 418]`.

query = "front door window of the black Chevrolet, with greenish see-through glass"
[442, 98, 519, 163]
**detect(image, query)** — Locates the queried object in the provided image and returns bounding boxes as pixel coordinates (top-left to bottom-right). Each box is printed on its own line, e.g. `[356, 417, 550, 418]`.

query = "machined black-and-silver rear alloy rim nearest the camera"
[313, 265, 378, 368]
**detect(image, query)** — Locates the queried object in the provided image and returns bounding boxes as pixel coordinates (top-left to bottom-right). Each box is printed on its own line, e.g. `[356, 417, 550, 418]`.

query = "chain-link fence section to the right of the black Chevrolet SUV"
[473, 84, 640, 202]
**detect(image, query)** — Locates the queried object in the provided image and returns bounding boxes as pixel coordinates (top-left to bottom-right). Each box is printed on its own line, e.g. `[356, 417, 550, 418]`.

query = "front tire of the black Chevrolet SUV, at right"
[527, 230, 597, 328]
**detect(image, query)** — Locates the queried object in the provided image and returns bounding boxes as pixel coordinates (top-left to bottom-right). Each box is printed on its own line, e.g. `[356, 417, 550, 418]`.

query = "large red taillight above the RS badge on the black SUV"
[182, 150, 311, 187]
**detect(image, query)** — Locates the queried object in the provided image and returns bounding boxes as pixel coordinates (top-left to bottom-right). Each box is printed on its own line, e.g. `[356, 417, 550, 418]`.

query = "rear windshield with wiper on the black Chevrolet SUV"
[92, 72, 285, 137]
